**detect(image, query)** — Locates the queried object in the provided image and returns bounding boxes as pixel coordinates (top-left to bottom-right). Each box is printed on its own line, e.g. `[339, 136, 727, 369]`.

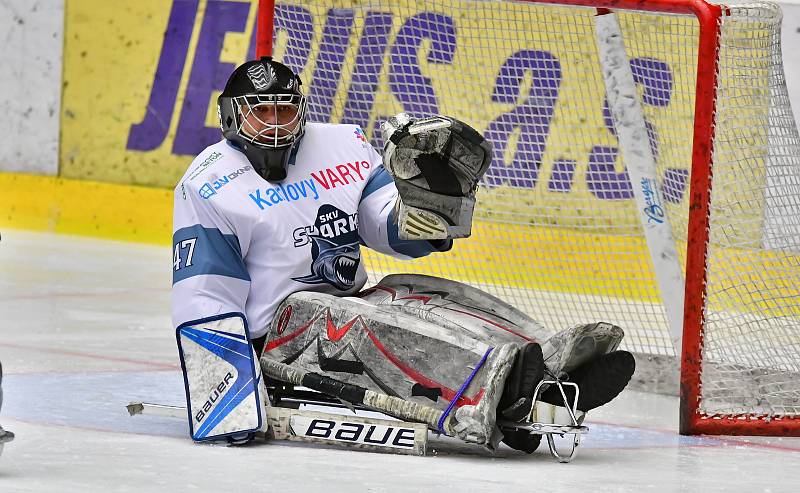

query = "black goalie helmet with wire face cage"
[217, 57, 306, 181]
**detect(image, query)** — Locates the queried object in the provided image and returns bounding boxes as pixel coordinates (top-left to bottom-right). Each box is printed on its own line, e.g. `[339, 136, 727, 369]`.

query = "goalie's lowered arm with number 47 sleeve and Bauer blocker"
[172, 182, 266, 443]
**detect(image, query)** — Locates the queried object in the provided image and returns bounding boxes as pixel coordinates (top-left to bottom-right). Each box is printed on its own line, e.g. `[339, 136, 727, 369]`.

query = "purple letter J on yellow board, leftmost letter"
[125, 0, 198, 151]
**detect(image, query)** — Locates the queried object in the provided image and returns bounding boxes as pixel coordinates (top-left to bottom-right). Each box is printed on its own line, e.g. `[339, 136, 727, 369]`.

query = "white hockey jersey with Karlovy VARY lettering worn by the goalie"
[172, 123, 446, 338]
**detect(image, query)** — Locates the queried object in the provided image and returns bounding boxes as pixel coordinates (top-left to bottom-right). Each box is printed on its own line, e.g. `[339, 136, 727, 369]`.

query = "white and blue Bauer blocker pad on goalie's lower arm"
[176, 313, 266, 443]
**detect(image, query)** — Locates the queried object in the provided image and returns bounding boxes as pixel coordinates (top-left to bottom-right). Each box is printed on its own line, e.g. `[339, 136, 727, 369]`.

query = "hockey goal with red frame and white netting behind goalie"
[258, 0, 800, 435]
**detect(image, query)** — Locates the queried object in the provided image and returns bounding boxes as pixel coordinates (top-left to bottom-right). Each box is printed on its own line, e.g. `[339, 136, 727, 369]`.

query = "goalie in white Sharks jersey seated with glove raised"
[172, 57, 634, 453]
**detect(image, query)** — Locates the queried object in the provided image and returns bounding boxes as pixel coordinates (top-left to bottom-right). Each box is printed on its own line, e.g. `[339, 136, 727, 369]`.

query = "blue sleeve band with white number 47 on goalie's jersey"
[172, 224, 250, 284]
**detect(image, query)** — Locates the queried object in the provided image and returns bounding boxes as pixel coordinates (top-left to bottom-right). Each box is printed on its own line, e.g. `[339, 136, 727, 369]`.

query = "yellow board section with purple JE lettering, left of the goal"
[60, 0, 255, 188]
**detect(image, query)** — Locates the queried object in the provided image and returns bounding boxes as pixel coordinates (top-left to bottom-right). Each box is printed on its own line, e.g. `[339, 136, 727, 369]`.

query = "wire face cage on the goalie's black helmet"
[231, 93, 306, 149]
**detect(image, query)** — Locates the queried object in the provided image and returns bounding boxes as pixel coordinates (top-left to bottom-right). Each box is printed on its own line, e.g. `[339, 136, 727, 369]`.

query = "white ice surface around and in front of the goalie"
[0, 230, 800, 493]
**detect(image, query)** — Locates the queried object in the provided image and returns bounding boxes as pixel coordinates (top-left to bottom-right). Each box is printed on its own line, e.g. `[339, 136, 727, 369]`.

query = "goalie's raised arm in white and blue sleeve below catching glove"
[358, 162, 453, 259]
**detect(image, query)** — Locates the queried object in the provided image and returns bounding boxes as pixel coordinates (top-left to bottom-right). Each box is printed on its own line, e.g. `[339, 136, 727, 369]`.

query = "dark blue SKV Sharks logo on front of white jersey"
[293, 204, 361, 291]
